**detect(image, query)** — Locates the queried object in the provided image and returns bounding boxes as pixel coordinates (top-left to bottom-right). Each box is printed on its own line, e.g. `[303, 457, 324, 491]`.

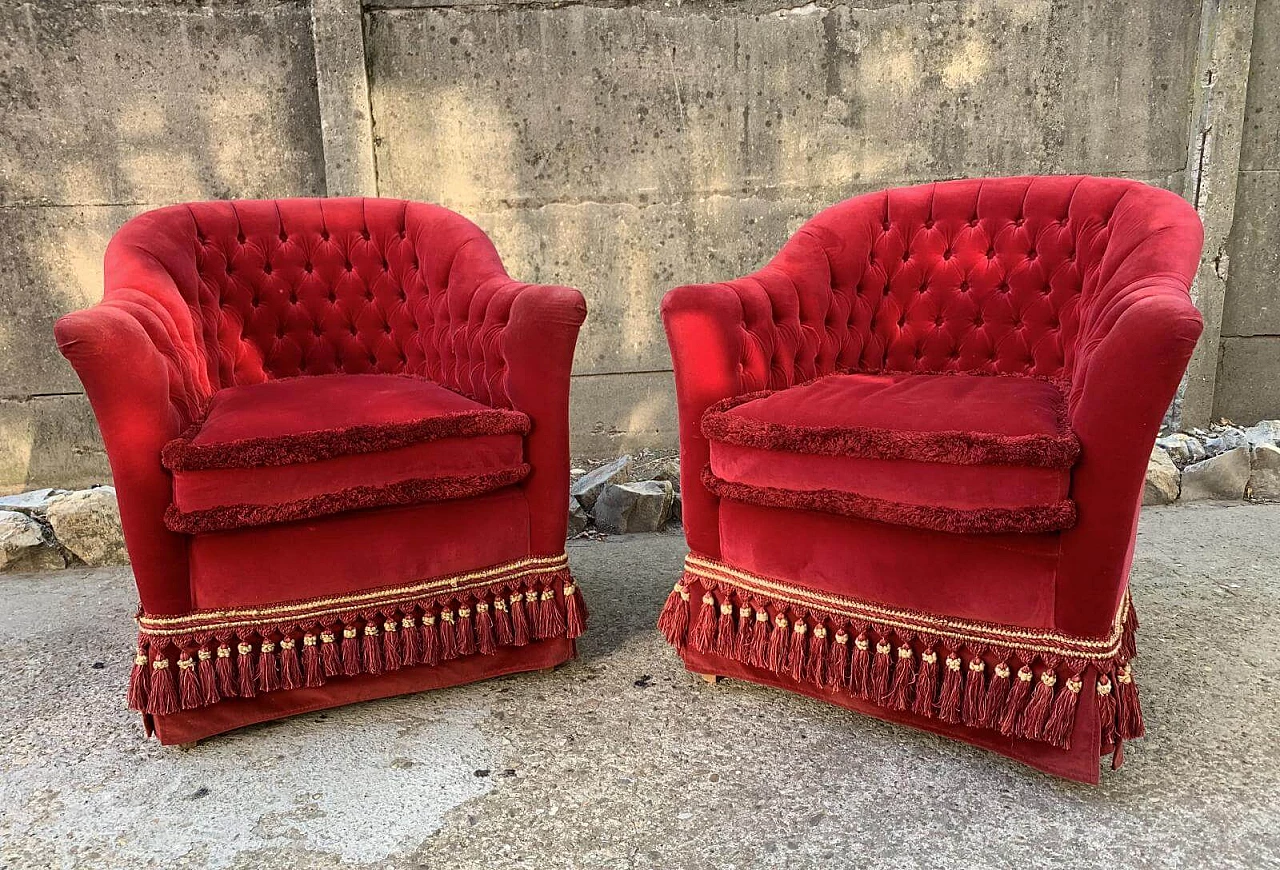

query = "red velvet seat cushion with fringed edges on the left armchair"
[161, 375, 530, 534]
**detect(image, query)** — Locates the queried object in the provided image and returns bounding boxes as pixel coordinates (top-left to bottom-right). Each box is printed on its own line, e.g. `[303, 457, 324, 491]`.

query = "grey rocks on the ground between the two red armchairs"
[568, 455, 680, 537]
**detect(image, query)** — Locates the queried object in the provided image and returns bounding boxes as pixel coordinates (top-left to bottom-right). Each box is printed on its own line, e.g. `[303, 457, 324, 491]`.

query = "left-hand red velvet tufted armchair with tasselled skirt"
[56, 198, 586, 743]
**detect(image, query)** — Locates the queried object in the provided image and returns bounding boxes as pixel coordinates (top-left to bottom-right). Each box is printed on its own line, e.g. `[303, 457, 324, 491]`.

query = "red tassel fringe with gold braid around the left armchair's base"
[128, 555, 586, 715]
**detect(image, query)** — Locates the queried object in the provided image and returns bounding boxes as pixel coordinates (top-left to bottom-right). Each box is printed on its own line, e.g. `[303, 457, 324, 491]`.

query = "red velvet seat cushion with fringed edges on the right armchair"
[703, 372, 1079, 534]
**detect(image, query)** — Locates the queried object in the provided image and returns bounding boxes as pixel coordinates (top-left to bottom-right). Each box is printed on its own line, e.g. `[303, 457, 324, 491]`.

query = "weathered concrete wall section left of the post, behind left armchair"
[0, 3, 324, 491]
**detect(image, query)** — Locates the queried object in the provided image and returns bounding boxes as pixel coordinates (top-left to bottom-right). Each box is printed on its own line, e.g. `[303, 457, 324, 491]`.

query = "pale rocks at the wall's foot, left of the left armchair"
[0, 486, 129, 573]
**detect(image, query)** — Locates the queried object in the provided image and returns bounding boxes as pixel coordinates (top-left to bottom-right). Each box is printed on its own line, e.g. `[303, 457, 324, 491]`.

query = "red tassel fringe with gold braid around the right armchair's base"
[659, 554, 1143, 766]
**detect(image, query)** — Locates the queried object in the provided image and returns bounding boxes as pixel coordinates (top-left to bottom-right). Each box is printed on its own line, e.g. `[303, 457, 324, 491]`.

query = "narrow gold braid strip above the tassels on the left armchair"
[137, 554, 568, 637]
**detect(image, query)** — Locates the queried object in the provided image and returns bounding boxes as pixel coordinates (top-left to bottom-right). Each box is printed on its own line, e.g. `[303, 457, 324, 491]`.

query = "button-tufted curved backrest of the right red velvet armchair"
[745, 177, 1199, 401]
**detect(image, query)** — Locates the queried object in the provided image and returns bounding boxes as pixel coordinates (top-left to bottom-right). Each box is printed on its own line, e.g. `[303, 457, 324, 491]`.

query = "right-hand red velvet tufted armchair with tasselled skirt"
[659, 177, 1202, 782]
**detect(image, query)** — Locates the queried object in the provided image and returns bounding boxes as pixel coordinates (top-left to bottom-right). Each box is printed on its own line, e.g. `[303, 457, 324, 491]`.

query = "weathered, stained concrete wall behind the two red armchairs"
[0, 0, 1280, 489]
